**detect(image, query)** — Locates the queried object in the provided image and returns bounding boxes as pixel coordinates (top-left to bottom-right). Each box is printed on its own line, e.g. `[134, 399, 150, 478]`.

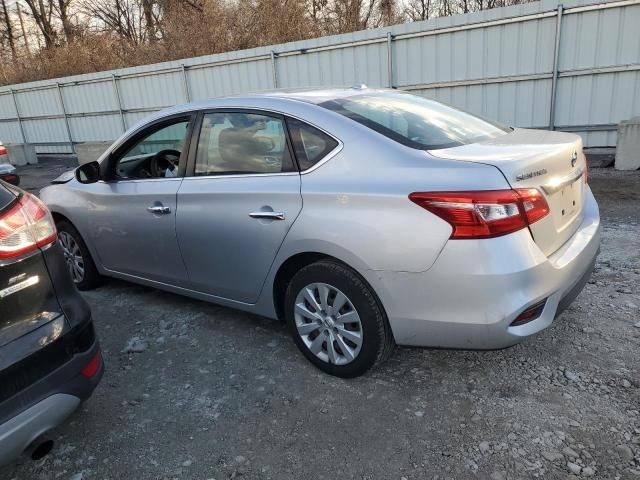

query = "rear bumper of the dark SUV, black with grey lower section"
[0, 321, 104, 465]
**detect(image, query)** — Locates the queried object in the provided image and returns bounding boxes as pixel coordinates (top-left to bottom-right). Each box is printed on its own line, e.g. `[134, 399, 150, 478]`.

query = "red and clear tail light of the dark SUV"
[0, 193, 57, 260]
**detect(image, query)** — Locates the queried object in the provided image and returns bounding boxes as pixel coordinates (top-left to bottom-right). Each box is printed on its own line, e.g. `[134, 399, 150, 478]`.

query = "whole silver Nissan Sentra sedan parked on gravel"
[41, 87, 600, 377]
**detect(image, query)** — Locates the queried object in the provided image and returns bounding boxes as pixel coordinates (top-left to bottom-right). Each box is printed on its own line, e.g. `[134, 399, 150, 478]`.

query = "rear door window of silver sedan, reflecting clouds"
[195, 112, 295, 175]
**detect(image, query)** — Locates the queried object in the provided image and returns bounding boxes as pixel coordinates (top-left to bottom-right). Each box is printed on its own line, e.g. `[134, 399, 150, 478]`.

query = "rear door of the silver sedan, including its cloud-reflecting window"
[176, 110, 302, 303]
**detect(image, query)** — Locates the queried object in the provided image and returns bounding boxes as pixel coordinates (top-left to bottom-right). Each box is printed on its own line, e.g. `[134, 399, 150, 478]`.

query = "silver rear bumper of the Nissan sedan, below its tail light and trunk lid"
[365, 190, 600, 349]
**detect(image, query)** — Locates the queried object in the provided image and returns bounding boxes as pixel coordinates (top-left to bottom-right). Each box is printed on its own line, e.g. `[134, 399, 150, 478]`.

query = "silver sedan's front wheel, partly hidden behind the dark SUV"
[56, 220, 102, 290]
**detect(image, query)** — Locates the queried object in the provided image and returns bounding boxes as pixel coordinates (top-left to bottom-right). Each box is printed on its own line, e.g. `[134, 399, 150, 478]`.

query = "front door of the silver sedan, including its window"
[87, 115, 195, 284]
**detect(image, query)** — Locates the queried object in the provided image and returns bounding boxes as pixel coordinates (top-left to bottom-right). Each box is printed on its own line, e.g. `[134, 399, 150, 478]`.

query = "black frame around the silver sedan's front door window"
[101, 111, 197, 183]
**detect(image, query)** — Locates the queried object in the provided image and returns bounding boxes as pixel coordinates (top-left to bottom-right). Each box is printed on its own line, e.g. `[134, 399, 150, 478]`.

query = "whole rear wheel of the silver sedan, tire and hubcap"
[285, 260, 394, 378]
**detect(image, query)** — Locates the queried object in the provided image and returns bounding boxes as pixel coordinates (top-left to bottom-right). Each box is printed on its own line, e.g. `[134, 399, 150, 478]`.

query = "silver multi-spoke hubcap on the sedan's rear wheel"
[294, 283, 363, 365]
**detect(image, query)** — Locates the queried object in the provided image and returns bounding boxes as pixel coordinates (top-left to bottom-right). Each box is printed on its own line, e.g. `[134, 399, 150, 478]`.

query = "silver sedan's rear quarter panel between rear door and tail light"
[276, 114, 509, 272]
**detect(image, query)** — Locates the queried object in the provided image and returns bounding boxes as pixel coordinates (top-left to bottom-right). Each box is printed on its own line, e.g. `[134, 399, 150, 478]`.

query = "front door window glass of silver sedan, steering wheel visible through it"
[115, 119, 189, 179]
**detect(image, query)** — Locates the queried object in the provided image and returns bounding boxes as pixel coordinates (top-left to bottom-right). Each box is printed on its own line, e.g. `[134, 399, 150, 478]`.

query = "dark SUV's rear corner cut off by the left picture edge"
[0, 181, 103, 465]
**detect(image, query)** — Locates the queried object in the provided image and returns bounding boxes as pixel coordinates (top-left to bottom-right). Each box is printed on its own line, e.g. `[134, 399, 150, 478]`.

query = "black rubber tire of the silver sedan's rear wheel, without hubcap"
[285, 260, 395, 378]
